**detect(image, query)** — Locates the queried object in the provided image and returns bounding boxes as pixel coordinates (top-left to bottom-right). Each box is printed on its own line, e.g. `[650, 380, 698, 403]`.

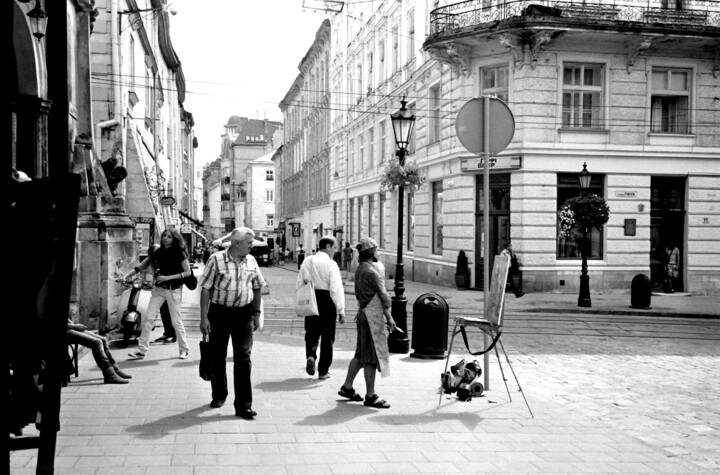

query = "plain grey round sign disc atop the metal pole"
[455, 97, 515, 155]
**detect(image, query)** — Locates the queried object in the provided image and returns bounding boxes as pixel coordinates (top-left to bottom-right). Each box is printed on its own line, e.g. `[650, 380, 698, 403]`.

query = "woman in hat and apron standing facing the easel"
[338, 238, 397, 409]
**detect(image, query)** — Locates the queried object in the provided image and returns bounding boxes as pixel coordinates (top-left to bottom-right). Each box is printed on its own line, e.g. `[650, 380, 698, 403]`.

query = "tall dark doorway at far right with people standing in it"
[650, 177, 685, 292]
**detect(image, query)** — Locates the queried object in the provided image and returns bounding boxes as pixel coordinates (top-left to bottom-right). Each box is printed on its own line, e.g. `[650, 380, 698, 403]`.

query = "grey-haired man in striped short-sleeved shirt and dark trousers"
[198, 227, 265, 419]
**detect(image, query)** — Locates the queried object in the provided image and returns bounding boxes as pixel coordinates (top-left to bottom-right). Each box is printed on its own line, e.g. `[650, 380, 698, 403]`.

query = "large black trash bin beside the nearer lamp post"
[410, 292, 450, 359]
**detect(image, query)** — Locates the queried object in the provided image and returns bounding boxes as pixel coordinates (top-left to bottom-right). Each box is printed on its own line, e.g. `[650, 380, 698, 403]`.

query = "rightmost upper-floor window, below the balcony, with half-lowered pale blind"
[650, 68, 692, 134]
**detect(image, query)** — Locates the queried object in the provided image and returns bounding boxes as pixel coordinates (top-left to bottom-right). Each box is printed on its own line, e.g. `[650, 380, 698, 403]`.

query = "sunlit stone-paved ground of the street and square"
[11, 266, 720, 474]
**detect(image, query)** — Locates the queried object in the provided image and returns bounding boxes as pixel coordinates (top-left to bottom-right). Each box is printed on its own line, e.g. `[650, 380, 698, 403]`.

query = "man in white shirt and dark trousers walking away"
[295, 236, 345, 379]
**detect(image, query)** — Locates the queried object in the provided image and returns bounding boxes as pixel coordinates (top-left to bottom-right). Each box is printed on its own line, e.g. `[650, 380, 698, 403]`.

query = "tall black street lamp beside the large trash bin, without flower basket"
[388, 97, 415, 353]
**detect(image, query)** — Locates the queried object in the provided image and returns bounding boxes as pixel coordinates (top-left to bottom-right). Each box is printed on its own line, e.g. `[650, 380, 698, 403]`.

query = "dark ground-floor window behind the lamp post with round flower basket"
[557, 173, 605, 259]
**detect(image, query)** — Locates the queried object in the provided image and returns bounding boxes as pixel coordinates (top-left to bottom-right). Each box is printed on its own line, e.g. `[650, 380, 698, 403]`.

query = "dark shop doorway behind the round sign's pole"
[475, 173, 510, 289]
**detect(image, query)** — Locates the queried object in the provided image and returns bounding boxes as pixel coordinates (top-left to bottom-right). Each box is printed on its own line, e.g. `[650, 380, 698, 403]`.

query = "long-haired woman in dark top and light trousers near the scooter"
[125, 228, 192, 360]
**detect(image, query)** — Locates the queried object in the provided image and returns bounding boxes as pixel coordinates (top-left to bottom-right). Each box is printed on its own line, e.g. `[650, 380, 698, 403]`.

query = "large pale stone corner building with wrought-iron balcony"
[330, 0, 720, 295]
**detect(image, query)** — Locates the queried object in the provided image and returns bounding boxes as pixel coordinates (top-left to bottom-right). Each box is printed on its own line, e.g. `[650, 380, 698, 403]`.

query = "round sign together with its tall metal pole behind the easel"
[455, 96, 515, 389]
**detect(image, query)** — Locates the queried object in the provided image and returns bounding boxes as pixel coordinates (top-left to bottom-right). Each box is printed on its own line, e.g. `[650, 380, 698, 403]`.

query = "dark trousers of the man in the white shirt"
[305, 290, 337, 375]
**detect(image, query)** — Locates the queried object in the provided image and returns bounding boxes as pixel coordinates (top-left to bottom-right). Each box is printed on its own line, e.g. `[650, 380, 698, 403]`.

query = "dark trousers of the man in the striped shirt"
[208, 303, 253, 411]
